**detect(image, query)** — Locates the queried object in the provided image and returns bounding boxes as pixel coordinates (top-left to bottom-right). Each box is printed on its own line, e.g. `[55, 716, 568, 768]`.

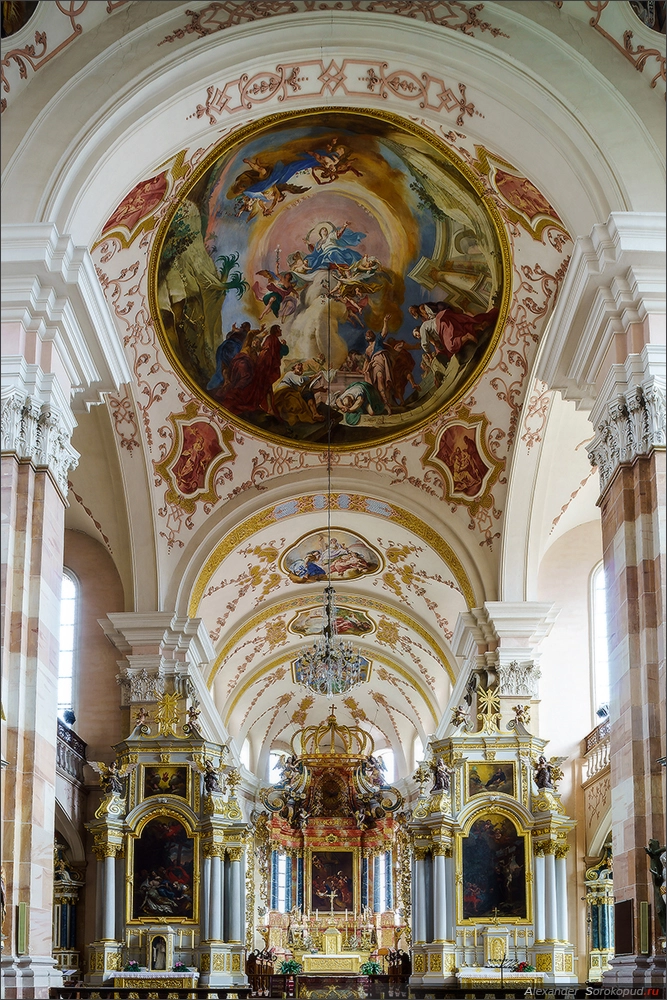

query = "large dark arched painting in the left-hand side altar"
[132, 816, 194, 922]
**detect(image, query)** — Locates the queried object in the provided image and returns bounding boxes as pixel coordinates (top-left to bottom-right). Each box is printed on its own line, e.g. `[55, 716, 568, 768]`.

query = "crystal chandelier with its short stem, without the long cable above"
[294, 585, 368, 698]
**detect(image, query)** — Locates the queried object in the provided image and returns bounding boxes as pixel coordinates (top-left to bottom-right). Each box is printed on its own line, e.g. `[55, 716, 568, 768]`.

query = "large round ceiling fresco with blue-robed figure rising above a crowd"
[151, 109, 510, 448]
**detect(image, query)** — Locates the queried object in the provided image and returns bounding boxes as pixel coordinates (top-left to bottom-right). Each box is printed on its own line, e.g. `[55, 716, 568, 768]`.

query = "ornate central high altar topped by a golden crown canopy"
[256, 710, 410, 975]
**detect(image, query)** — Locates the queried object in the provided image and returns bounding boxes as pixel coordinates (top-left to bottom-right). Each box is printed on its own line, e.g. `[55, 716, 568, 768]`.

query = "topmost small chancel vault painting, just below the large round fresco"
[281, 527, 382, 583]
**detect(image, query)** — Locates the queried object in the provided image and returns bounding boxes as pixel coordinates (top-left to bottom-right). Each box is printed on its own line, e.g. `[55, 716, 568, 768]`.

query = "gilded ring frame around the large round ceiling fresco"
[148, 105, 513, 452]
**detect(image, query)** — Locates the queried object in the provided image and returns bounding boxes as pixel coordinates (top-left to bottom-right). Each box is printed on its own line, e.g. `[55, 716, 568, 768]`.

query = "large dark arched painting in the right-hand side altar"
[462, 812, 527, 920]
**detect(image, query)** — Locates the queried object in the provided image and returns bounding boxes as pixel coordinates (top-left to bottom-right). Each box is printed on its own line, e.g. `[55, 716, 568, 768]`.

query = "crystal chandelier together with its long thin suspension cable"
[294, 272, 369, 698]
